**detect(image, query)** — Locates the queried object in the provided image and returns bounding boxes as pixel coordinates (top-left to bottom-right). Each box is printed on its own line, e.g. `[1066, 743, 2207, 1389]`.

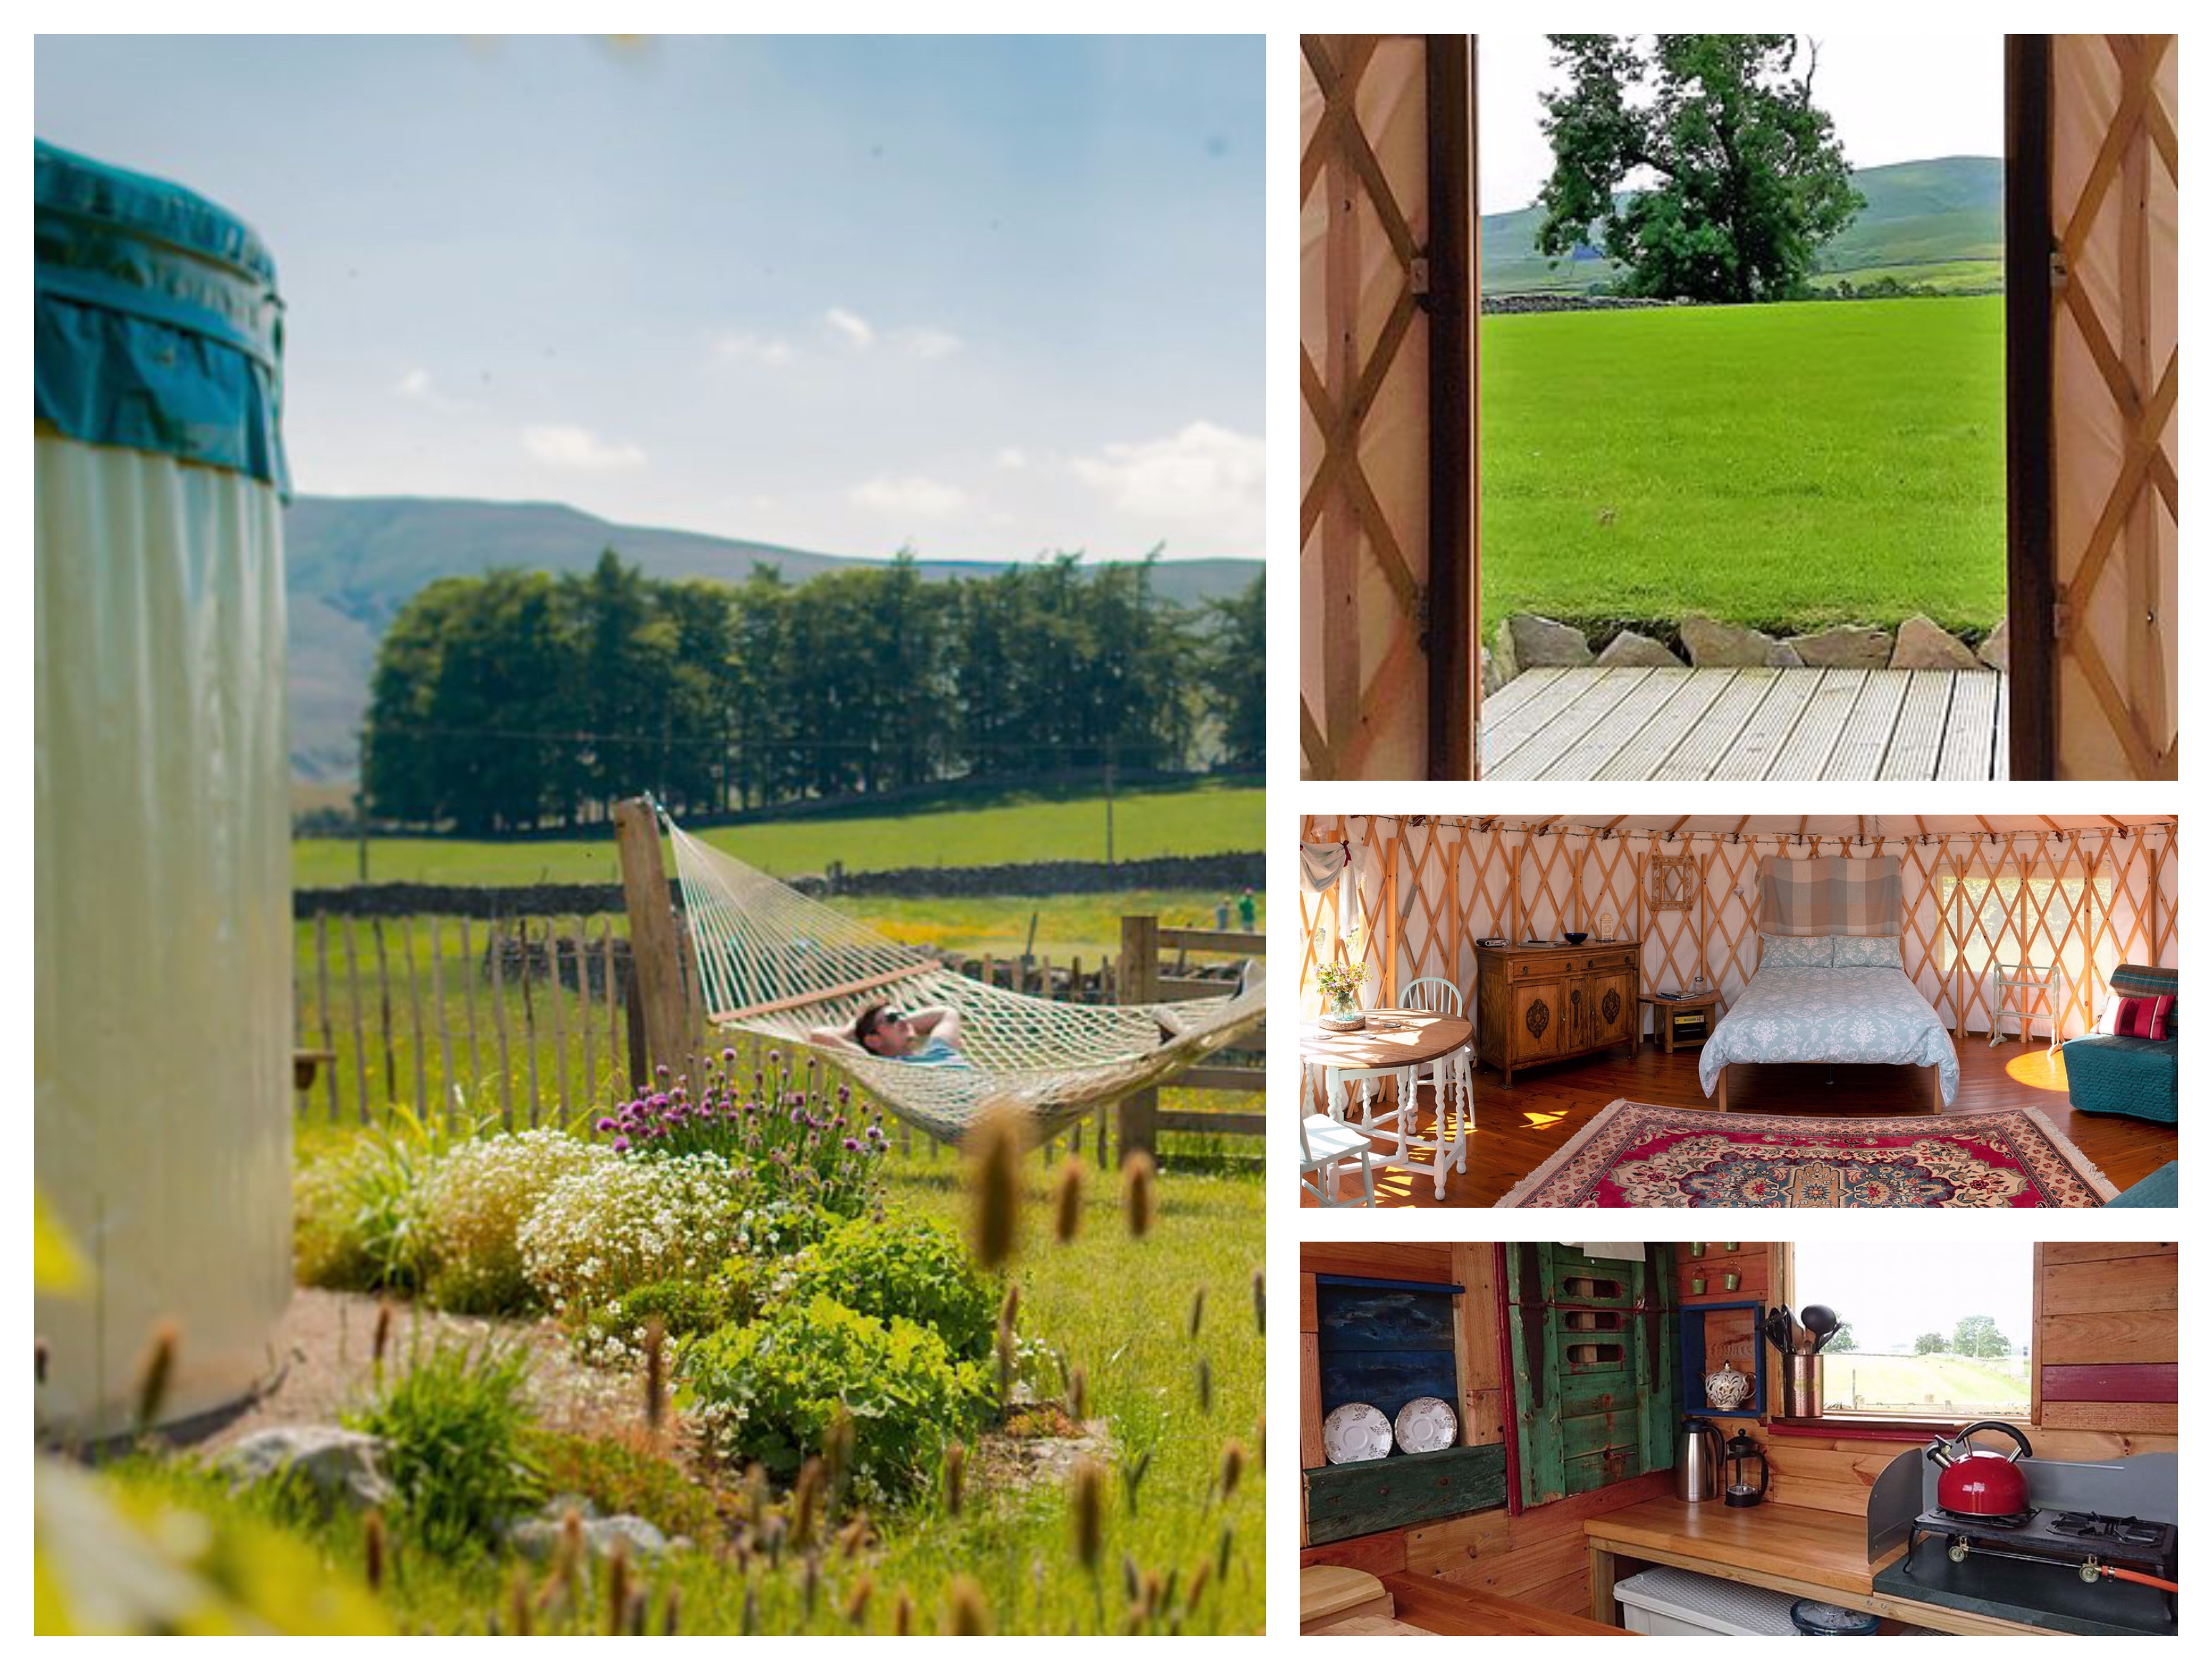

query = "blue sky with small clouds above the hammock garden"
[35, 35, 1265, 560]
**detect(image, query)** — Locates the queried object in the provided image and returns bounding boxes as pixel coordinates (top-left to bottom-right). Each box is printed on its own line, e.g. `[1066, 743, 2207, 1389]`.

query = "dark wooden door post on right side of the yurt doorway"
[2004, 35, 2057, 781]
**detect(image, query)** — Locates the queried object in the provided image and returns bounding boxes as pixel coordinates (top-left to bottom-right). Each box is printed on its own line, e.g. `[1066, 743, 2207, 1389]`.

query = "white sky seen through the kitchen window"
[1796, 1241, 2035, 1351]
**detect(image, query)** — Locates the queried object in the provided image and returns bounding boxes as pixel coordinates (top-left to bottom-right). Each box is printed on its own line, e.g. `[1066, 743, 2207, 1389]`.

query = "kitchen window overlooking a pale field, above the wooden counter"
[1792, 1241, 2035, 1422]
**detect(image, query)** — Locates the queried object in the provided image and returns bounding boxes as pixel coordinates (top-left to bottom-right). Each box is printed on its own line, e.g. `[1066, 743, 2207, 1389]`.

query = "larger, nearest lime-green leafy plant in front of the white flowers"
[679, 1294, 996, 1500]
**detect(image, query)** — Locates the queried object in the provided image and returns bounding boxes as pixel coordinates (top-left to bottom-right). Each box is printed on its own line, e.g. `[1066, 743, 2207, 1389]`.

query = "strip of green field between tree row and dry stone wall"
[292, 783, 1267, 887]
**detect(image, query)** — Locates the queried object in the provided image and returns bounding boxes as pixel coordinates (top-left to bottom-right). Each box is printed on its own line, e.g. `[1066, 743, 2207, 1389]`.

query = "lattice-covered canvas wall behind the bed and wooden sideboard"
[1298, 816, 2181, 1053]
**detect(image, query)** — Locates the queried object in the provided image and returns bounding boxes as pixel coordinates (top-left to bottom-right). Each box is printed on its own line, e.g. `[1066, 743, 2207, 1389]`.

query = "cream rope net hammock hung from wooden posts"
[661, 812, 1267, 1143]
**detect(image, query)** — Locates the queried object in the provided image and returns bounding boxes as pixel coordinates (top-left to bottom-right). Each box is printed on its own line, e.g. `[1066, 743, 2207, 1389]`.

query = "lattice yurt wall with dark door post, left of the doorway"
[1298, 35, 1480, 777]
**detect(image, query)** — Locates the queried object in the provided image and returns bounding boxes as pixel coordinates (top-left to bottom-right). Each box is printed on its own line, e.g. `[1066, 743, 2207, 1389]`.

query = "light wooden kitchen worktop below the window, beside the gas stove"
[1582, 1497, 2055, 1635]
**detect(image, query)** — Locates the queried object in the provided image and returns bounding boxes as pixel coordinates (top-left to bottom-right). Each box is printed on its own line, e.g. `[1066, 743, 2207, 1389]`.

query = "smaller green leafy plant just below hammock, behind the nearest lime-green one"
[777, 1212, 1004, 1362]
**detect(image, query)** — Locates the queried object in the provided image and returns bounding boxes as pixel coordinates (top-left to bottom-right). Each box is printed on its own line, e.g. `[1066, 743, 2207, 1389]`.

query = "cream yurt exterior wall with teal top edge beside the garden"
[33, 146, 292, 1438]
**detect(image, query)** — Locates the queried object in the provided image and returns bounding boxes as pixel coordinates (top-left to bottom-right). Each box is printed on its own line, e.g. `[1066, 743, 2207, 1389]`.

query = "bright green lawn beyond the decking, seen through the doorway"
[1482, 296, 2004, 630]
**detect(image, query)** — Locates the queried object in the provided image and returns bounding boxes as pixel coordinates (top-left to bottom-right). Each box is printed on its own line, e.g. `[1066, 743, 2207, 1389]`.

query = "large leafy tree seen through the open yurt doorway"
[1537, 35, 1865, 301]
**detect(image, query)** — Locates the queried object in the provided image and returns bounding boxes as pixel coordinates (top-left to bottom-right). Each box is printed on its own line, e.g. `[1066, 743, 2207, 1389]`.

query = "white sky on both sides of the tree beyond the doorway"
[1477, 31, 2004, 215]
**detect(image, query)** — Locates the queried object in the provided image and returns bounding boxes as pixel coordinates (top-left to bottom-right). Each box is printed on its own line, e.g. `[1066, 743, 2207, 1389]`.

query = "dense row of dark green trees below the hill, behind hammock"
[361, 551, 1267, 834]
